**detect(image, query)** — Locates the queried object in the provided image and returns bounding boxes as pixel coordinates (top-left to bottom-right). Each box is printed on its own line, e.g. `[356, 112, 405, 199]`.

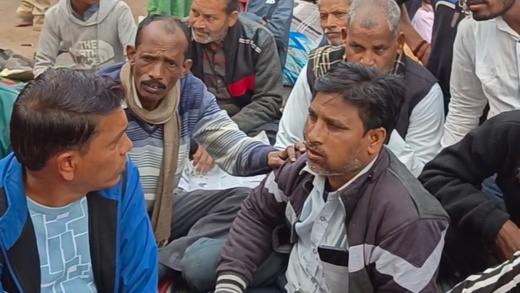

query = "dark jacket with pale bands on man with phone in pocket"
[216, 149, 449, 293]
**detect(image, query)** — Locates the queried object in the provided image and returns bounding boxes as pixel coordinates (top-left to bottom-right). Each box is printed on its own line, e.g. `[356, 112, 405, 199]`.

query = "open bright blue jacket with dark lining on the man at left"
[0, 154, 158, 293]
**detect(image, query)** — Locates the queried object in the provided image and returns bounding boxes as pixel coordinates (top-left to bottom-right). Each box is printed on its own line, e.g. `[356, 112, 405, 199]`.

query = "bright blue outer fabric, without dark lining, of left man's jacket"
[0, 154, 158, 293]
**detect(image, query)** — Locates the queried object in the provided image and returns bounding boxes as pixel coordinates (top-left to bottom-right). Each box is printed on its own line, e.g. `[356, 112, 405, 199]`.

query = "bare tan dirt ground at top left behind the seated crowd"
[0, 0, 147, 57]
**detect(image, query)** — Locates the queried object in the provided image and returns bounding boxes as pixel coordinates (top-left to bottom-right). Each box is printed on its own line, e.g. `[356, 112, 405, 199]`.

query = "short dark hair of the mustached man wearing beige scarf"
[135, 14, 190, 59]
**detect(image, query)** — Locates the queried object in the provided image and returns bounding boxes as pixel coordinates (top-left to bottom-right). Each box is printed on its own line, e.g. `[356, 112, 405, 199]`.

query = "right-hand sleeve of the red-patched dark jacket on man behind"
[232, 36, 283, 133]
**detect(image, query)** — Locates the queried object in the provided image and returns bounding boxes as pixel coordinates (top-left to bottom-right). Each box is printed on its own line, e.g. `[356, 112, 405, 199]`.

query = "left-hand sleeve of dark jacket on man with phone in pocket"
[215, 168, 288, 293]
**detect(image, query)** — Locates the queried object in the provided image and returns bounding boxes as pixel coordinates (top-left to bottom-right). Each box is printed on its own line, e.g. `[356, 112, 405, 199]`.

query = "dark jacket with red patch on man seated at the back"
[190, 18, 283, 133]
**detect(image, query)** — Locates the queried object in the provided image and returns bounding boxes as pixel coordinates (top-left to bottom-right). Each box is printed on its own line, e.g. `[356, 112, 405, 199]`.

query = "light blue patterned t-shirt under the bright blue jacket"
[27, 197, 97, 293]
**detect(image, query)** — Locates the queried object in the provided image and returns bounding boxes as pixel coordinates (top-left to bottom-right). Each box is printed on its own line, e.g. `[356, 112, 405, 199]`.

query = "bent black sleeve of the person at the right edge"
[419, 111, 520, 244]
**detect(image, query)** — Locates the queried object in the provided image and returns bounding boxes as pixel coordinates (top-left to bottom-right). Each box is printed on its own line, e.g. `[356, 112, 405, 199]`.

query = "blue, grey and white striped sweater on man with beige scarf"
[98, 63, 275, 210]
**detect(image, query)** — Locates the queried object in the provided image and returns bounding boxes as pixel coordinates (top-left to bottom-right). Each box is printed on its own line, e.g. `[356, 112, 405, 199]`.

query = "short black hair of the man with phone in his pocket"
[314, 62, 405, 138]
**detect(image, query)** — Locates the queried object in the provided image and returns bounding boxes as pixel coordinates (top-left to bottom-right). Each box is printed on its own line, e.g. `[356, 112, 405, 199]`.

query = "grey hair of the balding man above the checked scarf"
[347, 0, 401, 35]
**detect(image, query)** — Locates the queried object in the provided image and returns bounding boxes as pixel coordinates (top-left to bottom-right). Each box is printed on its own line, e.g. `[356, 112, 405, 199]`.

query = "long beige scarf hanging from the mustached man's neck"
[119, 62, 181, 246]
